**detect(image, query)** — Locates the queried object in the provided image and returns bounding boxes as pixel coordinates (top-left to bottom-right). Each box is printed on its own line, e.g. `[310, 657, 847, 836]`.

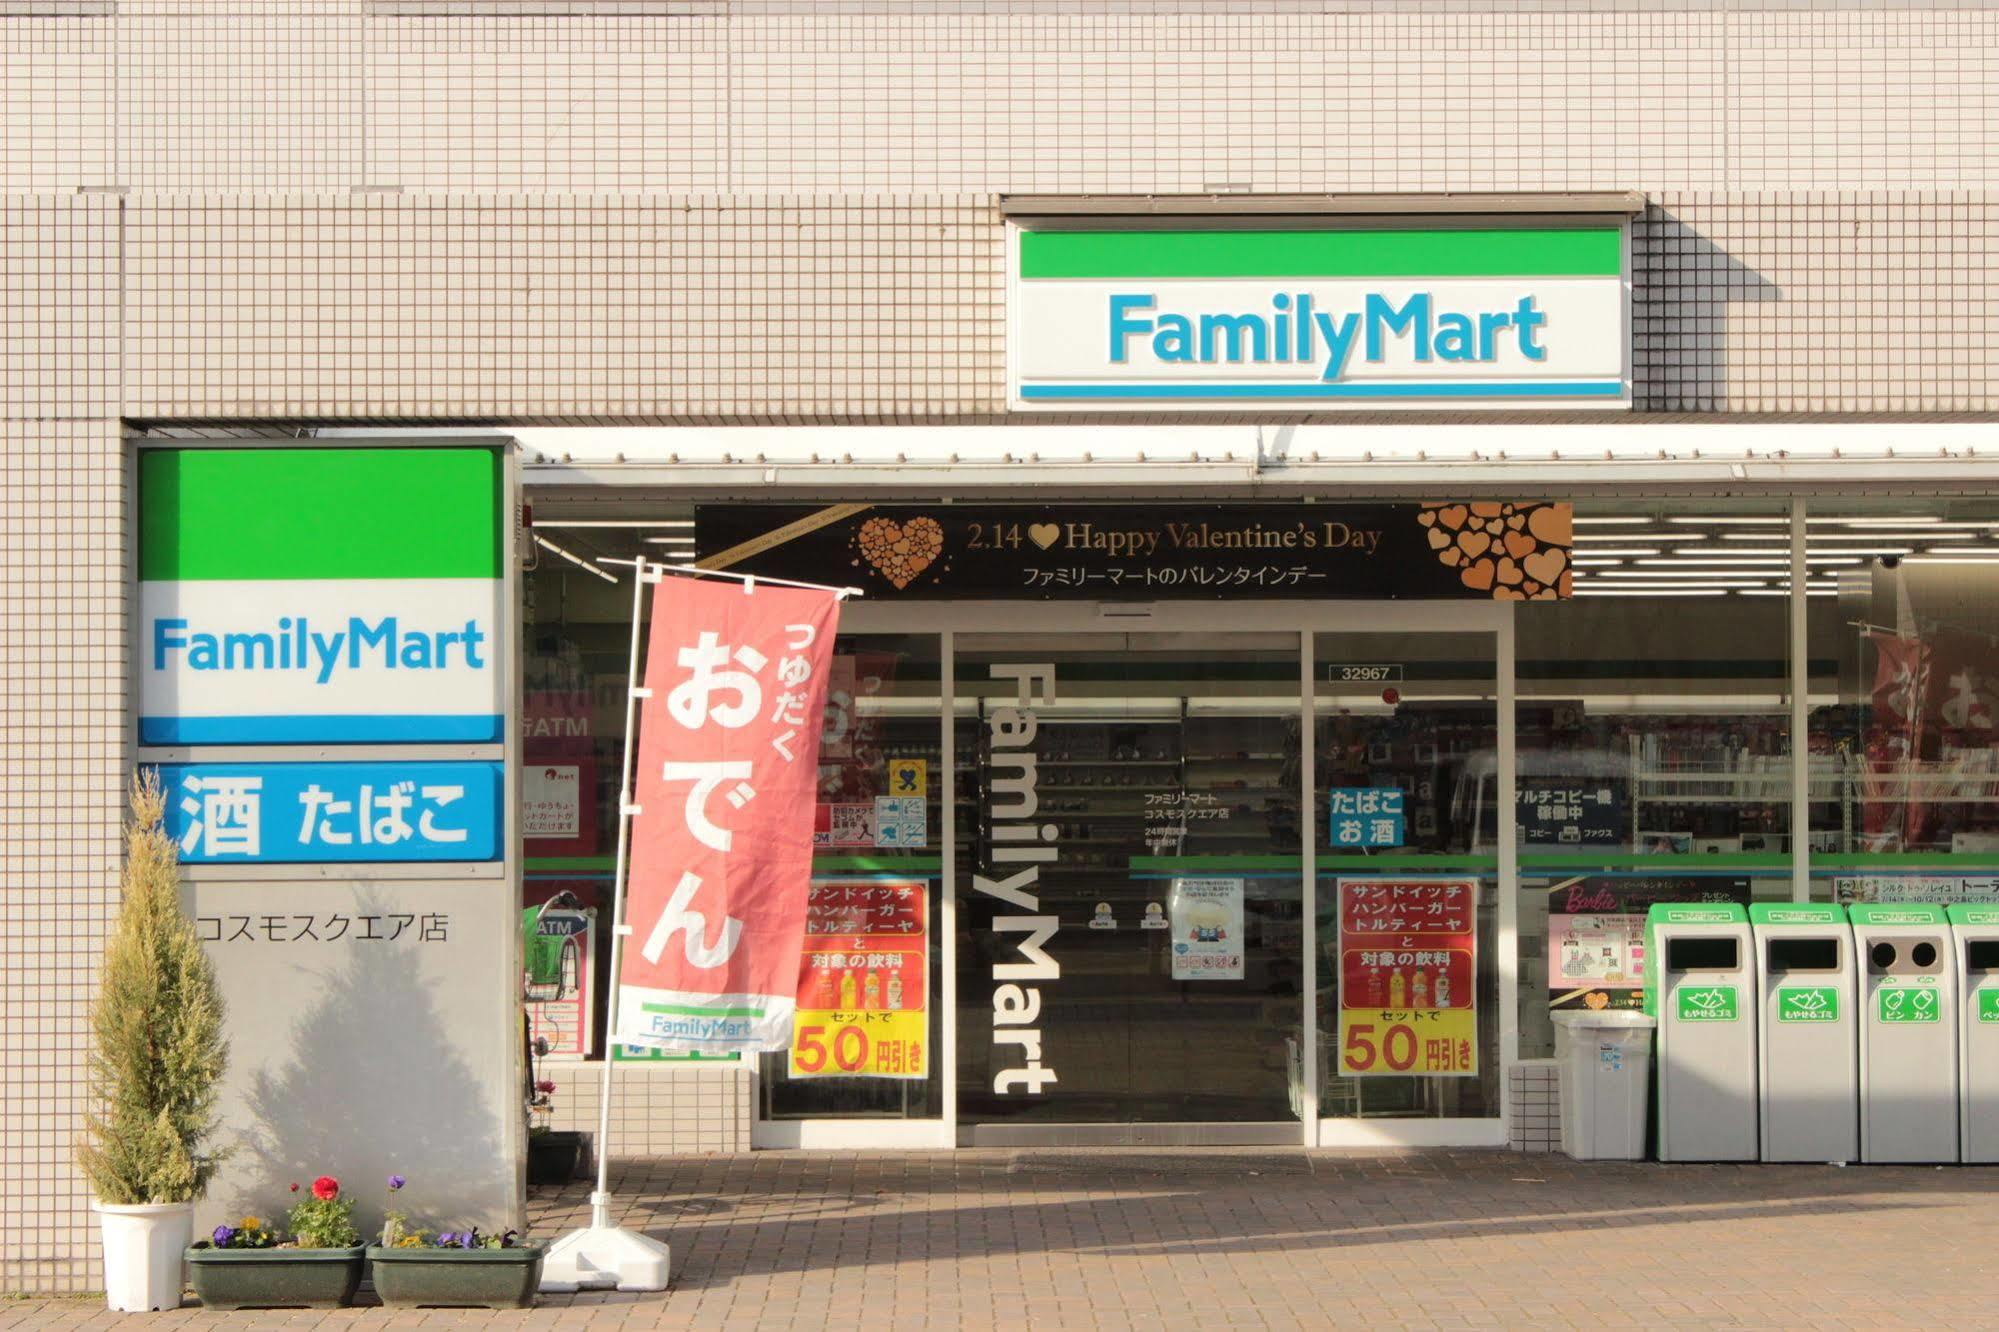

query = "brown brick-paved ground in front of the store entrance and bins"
[11, 1150, 1999, 1332]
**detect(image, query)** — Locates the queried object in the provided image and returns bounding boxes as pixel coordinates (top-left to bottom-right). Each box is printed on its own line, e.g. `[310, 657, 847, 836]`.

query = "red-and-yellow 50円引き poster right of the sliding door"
[1337, 878, 1479, 1078]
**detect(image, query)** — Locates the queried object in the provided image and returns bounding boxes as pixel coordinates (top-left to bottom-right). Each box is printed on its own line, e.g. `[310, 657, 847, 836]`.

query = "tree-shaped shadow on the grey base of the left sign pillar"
[212, 896, 502, 1236]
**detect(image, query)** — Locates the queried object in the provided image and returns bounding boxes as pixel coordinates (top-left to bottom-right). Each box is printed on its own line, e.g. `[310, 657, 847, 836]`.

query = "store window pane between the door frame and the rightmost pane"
[1515, 502, 1791, 1058]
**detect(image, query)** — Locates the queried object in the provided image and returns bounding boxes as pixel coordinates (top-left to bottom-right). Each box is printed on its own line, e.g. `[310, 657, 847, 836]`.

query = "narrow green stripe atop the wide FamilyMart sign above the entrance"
[1019, 226, 1623, 278]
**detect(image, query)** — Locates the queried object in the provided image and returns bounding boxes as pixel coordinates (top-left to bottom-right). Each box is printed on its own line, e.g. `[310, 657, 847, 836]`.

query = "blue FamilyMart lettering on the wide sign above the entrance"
[1109, 292, 1547, 384]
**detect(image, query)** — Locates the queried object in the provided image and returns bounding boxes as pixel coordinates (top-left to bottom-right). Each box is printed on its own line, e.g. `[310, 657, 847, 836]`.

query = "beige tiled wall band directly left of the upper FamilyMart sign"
[126, 194, 1003, 420]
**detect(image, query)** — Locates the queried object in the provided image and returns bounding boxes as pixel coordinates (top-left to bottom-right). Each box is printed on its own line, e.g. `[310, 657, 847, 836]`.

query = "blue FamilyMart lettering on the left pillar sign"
[152, 616, 488, 684]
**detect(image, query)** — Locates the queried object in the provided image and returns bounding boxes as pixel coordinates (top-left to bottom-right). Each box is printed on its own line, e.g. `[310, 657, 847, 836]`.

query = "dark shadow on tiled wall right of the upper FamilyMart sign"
[1631, 204, 1783, 412]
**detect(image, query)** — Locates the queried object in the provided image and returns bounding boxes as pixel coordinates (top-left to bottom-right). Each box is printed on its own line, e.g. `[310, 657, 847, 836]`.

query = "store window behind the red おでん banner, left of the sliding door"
[522, 540, 944, 1120]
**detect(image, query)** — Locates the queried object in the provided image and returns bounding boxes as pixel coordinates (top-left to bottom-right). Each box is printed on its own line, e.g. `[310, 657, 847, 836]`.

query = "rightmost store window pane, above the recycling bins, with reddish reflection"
[1807, 498, 1999, 902]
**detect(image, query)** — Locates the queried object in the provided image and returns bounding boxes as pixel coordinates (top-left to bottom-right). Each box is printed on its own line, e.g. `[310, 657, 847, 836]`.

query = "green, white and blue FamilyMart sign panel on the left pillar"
[136, 448, 506, 744]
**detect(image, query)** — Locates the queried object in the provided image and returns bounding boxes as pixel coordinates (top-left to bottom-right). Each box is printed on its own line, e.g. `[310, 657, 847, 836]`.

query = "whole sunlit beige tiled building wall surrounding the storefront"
[0, 0, 1999, 1288]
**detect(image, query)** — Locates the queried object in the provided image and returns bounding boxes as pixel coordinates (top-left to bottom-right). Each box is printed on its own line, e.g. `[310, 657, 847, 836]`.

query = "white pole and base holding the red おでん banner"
[542, 560, 668, 1292]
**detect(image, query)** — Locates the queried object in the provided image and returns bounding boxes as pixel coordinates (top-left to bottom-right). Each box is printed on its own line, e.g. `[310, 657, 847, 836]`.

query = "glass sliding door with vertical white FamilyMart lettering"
[956, 634, 1303, 1142]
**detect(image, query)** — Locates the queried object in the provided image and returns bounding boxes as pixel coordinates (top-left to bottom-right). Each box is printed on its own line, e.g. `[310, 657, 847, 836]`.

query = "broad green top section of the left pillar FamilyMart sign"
[138, 448, 502, 580]
